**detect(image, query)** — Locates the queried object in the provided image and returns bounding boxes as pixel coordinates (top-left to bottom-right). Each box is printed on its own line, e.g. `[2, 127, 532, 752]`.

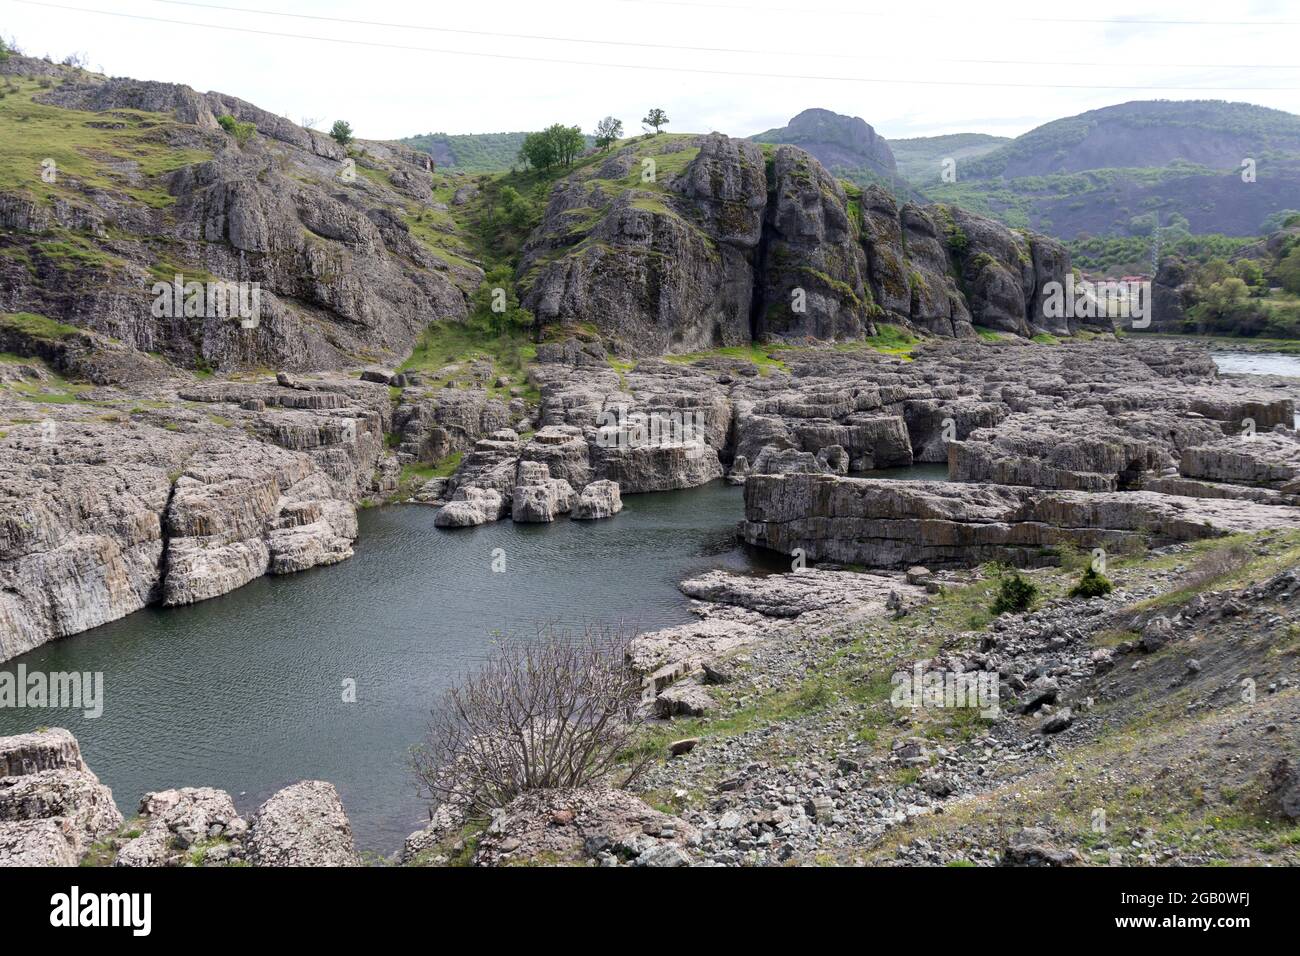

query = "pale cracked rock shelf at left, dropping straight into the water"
[0, 376, 391, 659]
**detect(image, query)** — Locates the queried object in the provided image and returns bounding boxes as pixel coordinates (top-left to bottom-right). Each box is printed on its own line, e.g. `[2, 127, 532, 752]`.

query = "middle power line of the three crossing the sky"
[144, 0, 1300, 70]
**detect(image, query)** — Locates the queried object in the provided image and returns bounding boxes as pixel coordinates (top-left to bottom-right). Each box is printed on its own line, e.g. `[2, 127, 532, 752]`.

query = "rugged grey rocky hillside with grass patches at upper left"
[0, 56, 482, 380]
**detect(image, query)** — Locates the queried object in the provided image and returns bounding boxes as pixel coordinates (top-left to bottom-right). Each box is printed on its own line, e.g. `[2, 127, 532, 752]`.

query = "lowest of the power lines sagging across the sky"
[10, 0, 1300, 92]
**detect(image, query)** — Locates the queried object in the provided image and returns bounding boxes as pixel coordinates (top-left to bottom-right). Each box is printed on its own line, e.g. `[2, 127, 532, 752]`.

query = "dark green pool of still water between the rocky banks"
[0, 466, 944, 853]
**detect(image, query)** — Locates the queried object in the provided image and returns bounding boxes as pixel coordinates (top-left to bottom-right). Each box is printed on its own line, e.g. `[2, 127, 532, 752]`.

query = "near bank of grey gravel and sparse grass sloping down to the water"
[403, 532, 1300, 866]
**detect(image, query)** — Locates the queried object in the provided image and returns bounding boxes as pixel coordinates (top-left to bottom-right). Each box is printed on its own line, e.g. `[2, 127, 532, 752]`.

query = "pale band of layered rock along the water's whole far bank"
[0, 339, 1300, 658]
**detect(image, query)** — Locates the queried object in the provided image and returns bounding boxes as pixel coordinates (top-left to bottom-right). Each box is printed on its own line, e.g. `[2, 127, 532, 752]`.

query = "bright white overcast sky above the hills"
[0, 0, 1300, 139]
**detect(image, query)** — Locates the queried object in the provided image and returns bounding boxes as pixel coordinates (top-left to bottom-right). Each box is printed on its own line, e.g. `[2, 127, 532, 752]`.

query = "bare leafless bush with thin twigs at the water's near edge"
[412, 628, 645, 814]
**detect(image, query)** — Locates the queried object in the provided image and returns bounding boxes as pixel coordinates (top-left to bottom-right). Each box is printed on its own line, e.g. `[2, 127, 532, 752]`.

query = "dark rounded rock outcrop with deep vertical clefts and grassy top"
[519, 133, 1076, 355]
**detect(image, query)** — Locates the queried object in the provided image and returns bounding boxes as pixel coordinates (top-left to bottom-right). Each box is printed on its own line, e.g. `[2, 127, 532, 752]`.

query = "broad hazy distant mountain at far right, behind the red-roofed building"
[918, 100, 1300, 239]
